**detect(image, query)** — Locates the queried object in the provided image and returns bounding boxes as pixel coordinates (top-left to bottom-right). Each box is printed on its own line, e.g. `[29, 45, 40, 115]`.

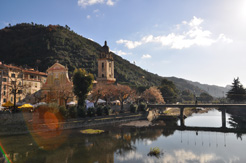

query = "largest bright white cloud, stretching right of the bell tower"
[116, 16, 233, 49]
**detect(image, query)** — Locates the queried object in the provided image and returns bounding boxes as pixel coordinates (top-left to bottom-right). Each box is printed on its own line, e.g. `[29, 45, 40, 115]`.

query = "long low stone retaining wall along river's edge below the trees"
[0, 113, 146, 135]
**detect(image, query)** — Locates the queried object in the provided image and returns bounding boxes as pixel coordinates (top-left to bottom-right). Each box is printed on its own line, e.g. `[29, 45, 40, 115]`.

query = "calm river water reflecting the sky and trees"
[0, 110, 246, 163]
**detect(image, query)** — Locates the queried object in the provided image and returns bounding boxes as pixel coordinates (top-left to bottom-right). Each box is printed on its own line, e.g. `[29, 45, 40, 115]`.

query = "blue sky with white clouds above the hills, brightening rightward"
[0, 0, 246, 86]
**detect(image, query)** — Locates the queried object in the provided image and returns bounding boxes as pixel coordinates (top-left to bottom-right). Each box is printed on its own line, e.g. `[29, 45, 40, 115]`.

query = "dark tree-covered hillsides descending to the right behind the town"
[0, 23, 229, 97]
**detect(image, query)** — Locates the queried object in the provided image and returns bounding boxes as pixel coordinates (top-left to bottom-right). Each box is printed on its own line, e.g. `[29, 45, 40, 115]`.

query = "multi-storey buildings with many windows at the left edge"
[0, 62, 47, 104]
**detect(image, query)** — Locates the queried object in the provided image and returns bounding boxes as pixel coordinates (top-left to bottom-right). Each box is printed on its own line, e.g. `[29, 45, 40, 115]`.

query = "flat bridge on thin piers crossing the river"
[148, 104, 246, 128]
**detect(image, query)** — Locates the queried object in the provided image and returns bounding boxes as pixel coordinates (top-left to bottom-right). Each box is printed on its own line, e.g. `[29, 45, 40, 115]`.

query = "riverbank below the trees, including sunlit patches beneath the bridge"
[0, 108, 213, 136]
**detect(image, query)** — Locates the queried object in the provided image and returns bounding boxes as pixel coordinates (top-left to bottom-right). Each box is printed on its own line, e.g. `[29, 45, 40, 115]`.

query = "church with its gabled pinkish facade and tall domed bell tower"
[42, 41, 116, 105]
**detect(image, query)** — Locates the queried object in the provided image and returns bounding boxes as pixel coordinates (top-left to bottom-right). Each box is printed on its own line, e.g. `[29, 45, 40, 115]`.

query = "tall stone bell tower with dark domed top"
[97, 41, 116, 83]
